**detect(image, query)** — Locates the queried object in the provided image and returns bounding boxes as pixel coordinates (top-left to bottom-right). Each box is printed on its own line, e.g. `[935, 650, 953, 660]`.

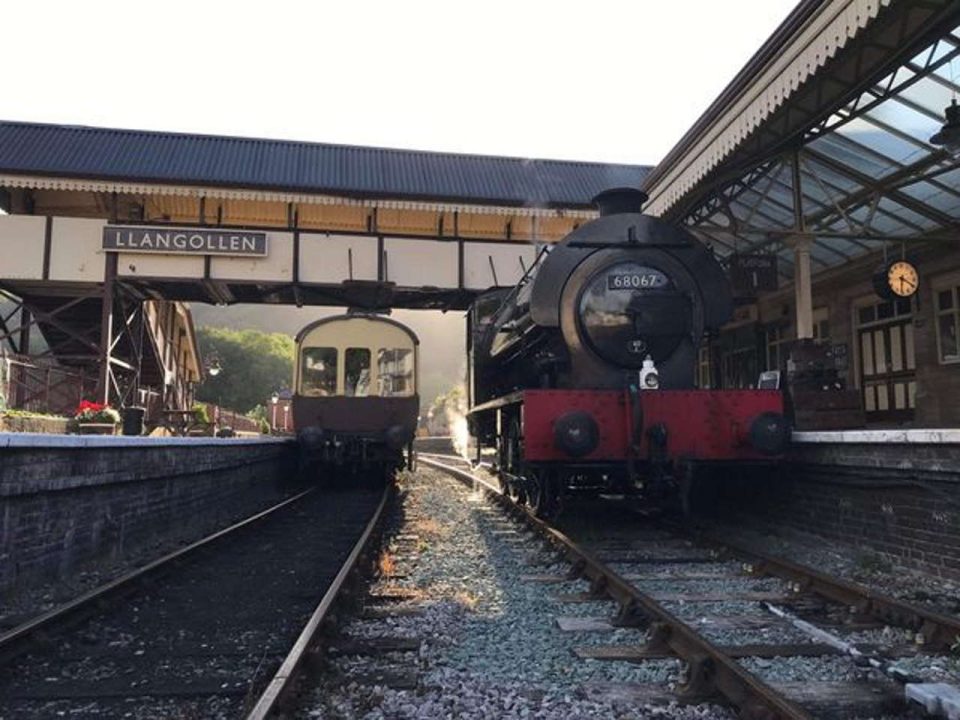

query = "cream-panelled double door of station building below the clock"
[857, 300, 917, 422]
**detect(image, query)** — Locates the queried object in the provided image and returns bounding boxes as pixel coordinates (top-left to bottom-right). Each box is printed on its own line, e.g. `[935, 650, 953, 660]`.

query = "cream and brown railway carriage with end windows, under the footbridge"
[292, 313, 420, 477]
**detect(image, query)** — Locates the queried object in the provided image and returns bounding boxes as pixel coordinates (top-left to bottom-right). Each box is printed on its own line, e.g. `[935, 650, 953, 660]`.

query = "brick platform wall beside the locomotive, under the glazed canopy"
[711, 443, 960, 580]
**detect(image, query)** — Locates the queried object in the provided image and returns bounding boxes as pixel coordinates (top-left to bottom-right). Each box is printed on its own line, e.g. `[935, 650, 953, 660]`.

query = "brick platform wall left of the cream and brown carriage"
[0, 436, 294, 593]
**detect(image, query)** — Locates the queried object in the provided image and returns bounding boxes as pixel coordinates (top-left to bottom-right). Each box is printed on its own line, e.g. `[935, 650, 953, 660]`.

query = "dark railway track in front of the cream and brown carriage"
[0, 488, 390, 720]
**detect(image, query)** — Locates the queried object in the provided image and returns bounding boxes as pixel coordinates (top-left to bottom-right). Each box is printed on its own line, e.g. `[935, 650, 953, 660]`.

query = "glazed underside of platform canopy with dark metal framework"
[686, 27, 960, 279]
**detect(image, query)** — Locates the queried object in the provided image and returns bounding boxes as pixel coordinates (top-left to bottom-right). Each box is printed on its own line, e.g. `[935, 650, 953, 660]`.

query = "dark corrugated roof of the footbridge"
[0, 121, 650, 208]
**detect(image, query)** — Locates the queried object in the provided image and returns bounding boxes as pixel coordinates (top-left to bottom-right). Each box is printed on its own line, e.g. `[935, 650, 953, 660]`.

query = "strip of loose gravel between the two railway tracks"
[303, 469, 733, 720]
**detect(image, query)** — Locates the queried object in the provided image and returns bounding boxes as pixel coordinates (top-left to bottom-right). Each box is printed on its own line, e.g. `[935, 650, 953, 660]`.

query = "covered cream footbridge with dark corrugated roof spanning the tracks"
[0, 122, 649, 406]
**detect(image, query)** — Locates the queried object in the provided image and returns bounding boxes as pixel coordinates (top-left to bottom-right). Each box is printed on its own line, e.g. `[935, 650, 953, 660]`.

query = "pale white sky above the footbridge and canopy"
[0, 0, 796, 164]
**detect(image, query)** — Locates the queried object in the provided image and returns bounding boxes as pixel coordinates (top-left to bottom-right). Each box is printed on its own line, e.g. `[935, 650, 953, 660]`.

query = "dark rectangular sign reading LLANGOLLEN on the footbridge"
[103, 225, 267, 257]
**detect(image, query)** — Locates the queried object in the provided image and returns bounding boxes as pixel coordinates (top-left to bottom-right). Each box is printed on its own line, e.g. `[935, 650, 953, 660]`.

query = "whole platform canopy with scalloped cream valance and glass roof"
[646, 0, 960, 279]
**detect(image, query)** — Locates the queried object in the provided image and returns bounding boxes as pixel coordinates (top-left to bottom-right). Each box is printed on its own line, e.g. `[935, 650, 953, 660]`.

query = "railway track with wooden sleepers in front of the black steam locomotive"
[421, 455, 960, 718]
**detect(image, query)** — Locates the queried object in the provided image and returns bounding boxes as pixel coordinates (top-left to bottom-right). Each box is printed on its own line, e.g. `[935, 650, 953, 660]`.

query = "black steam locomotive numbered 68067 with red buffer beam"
[467, 189, 789, 516]
